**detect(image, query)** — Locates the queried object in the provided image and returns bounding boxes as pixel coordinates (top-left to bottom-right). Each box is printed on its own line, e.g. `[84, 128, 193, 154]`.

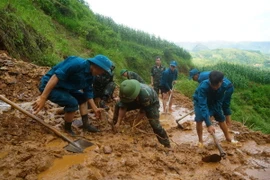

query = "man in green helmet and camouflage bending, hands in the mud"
[113, 79, 170, 148]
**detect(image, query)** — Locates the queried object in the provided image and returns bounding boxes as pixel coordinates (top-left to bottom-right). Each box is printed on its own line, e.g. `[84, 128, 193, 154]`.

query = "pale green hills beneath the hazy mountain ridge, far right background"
[191, 49, 270, 68]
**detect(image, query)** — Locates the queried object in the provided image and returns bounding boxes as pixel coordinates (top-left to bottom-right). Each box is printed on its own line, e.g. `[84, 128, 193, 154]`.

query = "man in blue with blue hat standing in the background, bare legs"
[160, 61, 178, 112]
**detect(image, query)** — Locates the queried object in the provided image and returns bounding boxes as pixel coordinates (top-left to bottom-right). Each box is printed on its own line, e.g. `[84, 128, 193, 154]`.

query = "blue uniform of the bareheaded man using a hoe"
[193, 78, 232, 127]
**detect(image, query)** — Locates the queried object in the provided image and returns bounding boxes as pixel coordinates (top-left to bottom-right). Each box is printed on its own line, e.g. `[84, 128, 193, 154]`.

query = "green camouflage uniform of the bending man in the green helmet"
[113, 83, 170, 147]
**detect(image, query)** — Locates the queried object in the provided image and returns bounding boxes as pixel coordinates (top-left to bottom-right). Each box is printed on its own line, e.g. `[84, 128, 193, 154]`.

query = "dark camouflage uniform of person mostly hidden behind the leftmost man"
[93, 73, 115, 101]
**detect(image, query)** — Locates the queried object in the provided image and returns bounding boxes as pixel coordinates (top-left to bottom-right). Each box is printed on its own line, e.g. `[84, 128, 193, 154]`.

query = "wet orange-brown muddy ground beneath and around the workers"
[0, 52, 270, 180]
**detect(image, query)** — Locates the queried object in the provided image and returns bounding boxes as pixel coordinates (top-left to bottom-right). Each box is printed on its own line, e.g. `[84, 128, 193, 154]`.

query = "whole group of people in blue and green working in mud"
[33, 55, 236, 148]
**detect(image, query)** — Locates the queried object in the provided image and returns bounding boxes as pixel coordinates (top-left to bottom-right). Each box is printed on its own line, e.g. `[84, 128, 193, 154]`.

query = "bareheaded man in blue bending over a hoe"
[193, 71, 235, 146]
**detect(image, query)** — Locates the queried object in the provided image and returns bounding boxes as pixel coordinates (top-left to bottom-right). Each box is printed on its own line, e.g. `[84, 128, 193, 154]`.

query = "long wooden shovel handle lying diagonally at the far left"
[0, 95, 81, 149]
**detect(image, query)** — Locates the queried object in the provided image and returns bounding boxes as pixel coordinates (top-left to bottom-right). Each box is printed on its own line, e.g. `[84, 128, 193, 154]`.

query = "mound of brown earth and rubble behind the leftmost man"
[0, 52, 49, 101]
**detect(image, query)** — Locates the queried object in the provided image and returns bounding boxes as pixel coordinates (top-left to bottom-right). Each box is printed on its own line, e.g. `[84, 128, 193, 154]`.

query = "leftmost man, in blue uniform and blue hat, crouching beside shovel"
[33, 55, 112, 135]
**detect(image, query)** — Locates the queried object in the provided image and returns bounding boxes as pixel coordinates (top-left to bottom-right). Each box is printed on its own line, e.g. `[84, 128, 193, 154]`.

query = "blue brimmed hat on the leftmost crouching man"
[87, 54, 113, 75]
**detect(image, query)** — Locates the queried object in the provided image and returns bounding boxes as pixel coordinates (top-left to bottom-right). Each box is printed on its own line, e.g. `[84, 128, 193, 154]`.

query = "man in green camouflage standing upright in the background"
[151, 57, 166, 94]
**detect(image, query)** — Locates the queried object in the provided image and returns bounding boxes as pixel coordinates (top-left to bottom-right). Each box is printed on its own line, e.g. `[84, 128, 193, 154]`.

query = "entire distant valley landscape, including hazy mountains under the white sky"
[177, 41, 270, 69]
